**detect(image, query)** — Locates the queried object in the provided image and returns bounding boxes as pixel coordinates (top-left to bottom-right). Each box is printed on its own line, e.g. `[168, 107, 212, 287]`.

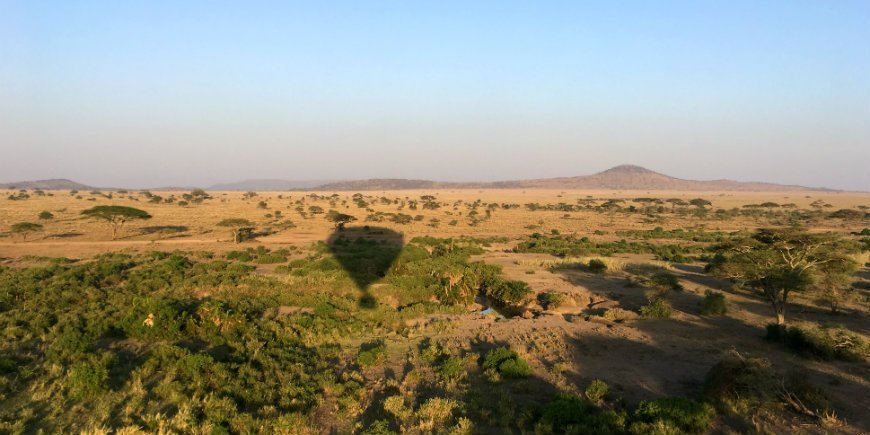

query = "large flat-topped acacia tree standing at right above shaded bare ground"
[707, 228, 846, 327]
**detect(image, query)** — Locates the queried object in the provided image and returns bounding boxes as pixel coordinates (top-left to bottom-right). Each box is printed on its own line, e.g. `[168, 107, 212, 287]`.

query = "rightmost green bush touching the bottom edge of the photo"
[632, 397, 716, 433]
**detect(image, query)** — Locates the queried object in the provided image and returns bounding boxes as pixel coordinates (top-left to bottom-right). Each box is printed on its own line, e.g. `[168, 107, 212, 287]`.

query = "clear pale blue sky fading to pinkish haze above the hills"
[0, 0, 870, 191]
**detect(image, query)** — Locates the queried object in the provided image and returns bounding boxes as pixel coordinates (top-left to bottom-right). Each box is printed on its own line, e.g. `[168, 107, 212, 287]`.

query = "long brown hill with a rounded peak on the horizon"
[314, 165, 831, 192]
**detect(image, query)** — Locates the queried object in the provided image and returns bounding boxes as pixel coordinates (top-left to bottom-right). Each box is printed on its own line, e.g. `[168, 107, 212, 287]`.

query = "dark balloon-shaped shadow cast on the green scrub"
[326, 226, 405, 308]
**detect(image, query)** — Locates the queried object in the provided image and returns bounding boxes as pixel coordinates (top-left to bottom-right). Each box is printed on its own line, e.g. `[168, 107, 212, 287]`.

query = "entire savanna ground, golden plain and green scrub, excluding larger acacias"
[0, 190, 870, 433]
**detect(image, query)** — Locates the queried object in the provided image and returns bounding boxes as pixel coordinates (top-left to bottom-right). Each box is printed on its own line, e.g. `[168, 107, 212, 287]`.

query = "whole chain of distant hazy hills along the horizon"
[0, 165, 836, 192]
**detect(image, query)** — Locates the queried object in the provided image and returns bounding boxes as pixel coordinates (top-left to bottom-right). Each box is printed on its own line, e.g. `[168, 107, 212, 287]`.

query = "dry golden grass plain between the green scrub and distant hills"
[0, 190, 870, 257]
